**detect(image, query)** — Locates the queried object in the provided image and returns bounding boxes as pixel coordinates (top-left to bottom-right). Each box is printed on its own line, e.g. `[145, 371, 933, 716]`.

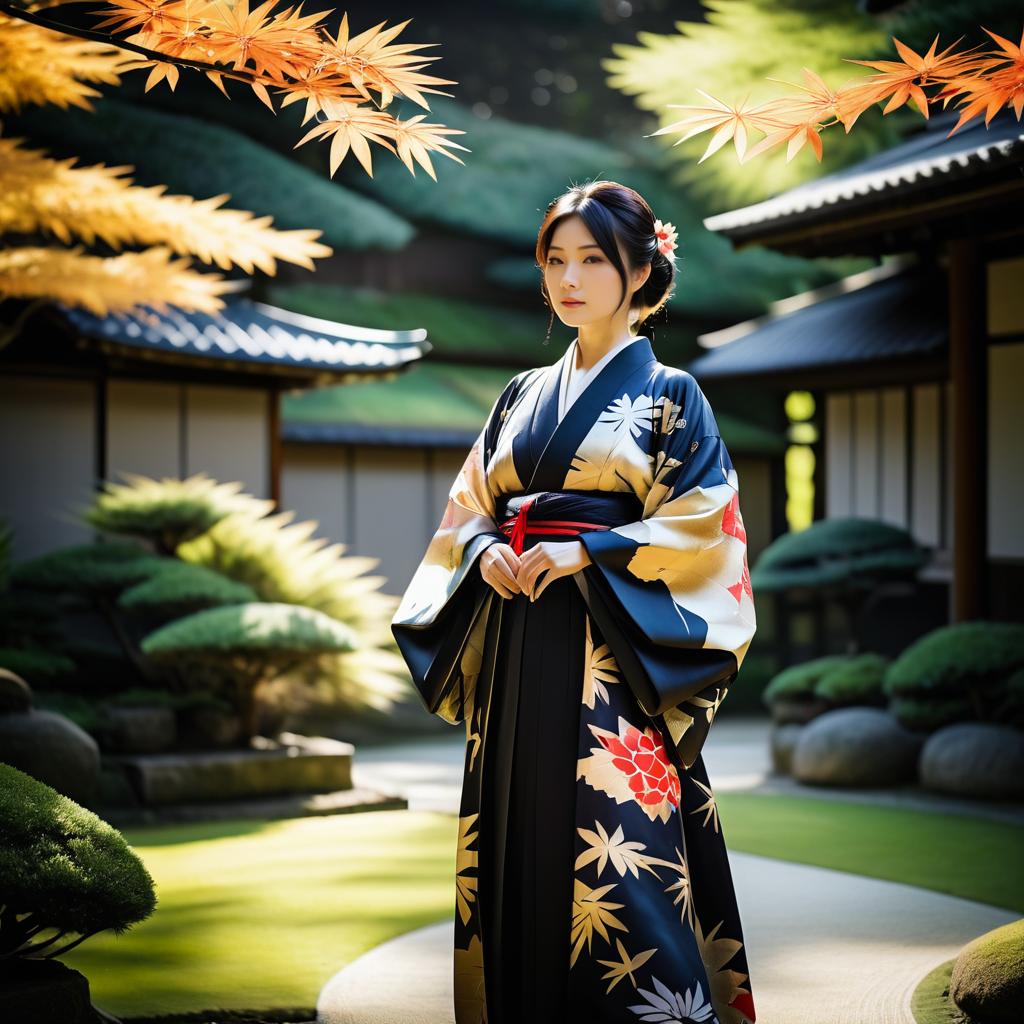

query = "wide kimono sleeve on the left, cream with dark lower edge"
[391, 375, 522, 725]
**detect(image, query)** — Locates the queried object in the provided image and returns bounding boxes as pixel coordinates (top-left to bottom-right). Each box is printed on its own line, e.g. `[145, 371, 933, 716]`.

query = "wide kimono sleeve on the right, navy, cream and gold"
[577, 373, 756, 768]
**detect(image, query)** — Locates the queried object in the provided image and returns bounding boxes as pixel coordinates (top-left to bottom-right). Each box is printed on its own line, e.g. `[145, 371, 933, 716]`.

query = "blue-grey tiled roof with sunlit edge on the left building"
[55, 297, 431, 376]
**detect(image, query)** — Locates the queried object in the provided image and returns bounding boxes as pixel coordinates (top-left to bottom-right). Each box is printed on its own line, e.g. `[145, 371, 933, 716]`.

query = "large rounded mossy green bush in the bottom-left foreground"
[0, 764, 157, 958]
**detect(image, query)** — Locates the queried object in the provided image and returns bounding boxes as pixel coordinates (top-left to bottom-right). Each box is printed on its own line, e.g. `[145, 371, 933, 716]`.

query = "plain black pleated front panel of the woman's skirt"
[479, 565, 586, 1024]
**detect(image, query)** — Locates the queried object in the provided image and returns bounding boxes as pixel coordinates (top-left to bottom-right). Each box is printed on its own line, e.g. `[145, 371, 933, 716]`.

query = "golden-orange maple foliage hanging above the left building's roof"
[0, 0, 465, 315]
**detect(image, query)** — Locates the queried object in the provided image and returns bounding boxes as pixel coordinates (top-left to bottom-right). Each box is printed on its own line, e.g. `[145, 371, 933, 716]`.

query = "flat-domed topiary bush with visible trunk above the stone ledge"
[142, 602, 357, 744]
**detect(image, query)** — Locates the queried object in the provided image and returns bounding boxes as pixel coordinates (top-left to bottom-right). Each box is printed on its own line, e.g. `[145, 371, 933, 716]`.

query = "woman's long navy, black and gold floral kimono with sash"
[391, 337, 755, 1024]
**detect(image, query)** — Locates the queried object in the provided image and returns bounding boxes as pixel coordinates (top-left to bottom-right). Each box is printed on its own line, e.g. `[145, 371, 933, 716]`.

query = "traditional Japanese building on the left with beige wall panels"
[0, 296, 430, 560]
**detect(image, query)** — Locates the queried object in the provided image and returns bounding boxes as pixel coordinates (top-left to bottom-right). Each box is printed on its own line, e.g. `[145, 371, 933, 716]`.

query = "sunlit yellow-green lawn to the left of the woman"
[60, 811, 458, 1017]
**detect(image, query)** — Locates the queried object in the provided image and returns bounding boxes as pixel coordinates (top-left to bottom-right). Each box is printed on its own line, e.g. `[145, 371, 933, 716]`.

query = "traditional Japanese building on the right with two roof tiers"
[688, 112, 1024, 620]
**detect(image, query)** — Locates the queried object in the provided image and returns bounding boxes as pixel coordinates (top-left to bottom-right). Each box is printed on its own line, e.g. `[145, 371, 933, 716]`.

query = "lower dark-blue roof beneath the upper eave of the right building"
[686, 264, 948, 380]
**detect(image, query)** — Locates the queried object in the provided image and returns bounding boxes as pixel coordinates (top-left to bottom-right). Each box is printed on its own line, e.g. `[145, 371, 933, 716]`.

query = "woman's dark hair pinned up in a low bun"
[536, 180, 676, 344]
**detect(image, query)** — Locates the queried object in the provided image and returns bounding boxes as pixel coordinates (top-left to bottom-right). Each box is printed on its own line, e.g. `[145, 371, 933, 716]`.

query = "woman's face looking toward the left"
[544, 215, 650, 328]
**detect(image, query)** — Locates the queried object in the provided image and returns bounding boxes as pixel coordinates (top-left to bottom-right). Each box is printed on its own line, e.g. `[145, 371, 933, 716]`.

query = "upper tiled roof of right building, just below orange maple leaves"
[703, 111, 1024, 239]
